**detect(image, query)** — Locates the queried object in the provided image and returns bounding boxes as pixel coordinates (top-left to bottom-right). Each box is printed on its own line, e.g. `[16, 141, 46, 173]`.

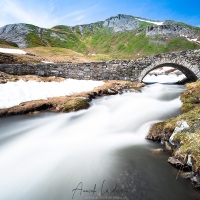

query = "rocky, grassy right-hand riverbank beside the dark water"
[146, 81, 200, 189]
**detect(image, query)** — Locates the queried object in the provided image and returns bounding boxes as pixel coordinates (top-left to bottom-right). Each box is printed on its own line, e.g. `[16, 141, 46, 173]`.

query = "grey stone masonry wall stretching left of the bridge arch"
[0, 61, 144, 81]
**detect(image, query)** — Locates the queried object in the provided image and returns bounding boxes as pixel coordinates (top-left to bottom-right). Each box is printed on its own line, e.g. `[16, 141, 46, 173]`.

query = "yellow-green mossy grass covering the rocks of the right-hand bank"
[147, 81, 200, 175]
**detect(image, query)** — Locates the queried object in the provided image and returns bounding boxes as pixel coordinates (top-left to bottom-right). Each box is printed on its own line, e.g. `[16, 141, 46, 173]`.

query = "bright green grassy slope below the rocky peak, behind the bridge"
[85, 32, 200, 59]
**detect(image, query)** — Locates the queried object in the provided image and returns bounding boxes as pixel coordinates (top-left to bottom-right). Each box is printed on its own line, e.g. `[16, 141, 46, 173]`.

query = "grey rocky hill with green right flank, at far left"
[0, 23, 84, 48]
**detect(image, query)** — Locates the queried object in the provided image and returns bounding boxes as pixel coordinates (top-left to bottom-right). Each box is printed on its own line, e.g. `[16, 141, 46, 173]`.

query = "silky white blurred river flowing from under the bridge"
[0, 84, 199, 200]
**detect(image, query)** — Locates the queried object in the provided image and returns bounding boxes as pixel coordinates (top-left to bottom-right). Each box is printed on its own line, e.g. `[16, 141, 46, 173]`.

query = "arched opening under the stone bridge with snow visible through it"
[139, 63, 198, 84]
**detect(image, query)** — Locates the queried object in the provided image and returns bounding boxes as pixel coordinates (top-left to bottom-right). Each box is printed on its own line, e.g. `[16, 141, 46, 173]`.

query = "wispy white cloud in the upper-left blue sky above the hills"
[0, 0, 102, 28]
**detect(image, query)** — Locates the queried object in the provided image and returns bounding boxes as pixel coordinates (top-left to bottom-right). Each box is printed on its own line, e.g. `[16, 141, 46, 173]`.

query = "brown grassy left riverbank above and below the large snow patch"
[0, 72, 144, 117]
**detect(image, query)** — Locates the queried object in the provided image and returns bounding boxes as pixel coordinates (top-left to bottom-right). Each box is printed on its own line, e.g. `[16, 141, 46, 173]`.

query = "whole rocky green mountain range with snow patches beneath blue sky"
[0, 14, 200, 59]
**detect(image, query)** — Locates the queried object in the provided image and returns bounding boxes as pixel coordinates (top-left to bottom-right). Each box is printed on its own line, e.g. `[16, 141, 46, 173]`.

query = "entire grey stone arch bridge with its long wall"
[0, 49, 200, 82]
